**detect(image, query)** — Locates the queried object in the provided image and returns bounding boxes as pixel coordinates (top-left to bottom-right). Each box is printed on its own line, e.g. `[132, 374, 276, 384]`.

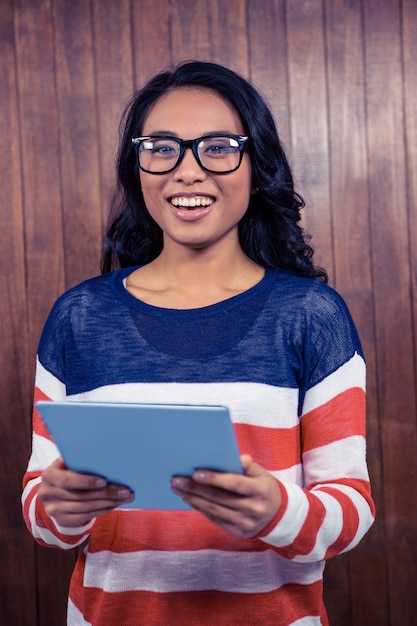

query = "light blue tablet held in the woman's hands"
[36, 401, 243, 510]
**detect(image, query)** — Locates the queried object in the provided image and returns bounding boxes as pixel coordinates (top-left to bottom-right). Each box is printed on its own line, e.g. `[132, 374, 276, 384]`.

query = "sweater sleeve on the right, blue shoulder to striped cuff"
[261, 294, 375, 562]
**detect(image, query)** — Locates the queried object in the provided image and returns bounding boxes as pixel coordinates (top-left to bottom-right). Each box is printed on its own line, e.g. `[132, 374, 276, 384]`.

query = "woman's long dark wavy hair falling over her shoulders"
[101, 61, 327, 282]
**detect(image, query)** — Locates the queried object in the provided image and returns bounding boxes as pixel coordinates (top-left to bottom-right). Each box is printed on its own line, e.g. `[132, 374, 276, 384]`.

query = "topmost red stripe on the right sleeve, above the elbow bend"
[301, 387, 365, 452]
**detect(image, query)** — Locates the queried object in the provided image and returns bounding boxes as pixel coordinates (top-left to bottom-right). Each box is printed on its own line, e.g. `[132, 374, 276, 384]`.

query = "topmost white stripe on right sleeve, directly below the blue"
[303, 353, 366, 415]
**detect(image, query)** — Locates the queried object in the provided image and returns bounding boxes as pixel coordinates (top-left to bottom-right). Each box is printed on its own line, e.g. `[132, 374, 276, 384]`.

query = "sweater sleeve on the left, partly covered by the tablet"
[22, 296, 94, 549]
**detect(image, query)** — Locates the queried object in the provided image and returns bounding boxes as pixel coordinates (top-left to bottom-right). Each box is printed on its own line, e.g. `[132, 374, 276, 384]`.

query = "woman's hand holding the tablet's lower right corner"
[172, 454, 282, 538]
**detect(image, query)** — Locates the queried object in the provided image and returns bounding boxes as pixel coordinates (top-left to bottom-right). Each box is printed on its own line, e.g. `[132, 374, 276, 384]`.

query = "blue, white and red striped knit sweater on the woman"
[22, 268, 374, 626]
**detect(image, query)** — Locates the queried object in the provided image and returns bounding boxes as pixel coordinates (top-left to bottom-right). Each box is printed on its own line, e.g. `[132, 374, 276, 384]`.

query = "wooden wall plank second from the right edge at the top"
[364, 0, 417, 626]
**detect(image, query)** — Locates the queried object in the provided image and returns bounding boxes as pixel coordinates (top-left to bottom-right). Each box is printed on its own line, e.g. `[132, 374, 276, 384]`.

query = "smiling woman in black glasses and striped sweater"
[23, 62, 374, 626]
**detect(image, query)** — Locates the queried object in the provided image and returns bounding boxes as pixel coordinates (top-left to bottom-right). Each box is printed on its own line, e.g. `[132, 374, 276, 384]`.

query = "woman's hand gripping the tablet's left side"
[39, 458, 134, 528]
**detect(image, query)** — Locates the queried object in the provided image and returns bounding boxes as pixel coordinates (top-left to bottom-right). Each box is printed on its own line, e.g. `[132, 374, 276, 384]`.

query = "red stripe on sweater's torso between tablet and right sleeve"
[234, 424, 301, 471]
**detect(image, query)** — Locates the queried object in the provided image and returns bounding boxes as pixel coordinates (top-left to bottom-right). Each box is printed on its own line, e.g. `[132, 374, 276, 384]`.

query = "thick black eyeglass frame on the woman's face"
[132, 133, 249, 176]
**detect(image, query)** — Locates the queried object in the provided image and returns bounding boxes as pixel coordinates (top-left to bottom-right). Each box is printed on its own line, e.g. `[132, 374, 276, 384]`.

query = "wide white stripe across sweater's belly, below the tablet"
[84, 550, 324, 593]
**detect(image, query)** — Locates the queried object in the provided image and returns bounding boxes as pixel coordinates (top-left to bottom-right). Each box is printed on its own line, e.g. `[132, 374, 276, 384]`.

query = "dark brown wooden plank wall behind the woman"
[0, 0, 417, 626]
